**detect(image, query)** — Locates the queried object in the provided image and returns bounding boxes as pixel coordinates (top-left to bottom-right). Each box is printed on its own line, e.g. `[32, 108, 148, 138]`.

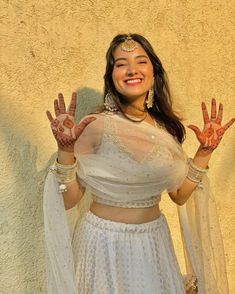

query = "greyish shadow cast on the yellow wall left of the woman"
[0, 88, 102, 293]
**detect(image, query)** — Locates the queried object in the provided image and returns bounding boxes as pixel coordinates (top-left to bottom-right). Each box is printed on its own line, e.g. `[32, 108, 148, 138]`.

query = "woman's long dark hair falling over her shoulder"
[104, 34, 185, 143]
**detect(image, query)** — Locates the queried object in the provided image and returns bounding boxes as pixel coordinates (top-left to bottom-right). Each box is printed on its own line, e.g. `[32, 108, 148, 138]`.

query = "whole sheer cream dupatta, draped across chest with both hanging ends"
[44, 113, 228, 294]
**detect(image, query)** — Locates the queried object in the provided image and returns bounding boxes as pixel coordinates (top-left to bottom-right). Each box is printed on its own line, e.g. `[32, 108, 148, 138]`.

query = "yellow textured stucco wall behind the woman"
[0, 0, 235, 294]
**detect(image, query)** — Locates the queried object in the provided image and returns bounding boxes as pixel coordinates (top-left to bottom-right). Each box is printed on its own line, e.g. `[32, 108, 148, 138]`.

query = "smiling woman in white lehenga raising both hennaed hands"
[44, 34, 234, 294]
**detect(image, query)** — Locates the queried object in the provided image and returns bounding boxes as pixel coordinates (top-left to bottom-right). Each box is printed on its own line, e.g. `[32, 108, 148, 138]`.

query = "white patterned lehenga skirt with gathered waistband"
[72, 211, 185, 294]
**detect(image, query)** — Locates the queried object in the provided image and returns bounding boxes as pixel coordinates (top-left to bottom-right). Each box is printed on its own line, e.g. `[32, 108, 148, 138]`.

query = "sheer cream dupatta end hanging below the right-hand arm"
[178, 176, 229, 294]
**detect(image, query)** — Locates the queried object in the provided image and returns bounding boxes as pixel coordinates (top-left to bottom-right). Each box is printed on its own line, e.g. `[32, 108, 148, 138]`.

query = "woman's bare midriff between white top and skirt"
[90, 201, 161, 224]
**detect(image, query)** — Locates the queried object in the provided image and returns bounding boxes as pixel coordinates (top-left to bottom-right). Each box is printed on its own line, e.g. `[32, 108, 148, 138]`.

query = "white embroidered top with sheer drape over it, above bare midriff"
[75, 114, 187, 208]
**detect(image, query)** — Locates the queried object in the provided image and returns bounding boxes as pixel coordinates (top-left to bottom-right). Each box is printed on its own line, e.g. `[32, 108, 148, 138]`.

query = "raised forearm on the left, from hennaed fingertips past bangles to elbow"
[46, 92, 96, 209]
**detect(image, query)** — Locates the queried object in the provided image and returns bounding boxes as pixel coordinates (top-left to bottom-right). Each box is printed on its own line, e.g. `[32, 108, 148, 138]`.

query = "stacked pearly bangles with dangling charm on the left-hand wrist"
[49, 158, 78, 192]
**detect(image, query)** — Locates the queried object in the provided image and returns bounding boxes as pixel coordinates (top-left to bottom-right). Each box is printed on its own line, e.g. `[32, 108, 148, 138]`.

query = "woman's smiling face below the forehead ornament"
[112, 44, 153, 103]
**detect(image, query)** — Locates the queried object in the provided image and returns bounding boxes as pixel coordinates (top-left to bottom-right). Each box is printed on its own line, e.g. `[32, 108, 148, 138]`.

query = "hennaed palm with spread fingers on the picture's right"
[188, 98, 235, 153]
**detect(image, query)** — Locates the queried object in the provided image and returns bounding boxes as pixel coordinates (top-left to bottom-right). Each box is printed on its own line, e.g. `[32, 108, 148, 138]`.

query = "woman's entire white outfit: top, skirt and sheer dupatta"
[44, 113, 228, 294]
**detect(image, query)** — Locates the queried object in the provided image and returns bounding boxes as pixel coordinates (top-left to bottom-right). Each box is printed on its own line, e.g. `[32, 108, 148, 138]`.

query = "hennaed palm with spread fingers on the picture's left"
[46, 92, 96, 152]
